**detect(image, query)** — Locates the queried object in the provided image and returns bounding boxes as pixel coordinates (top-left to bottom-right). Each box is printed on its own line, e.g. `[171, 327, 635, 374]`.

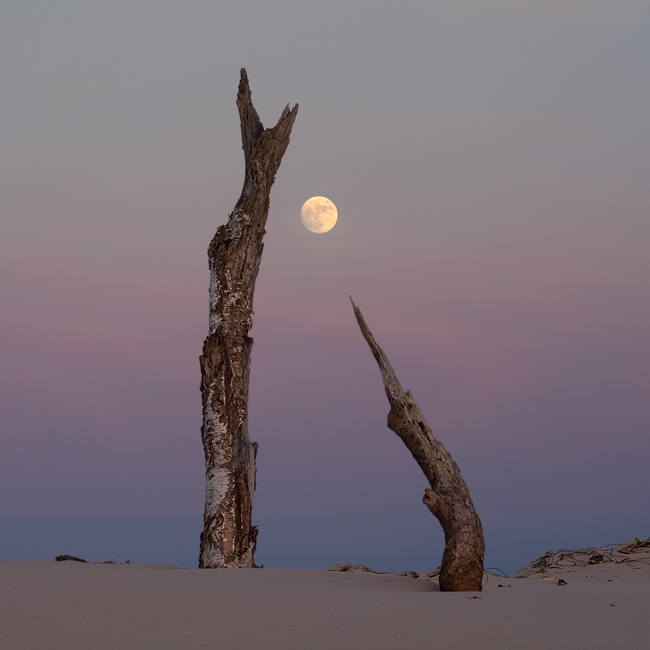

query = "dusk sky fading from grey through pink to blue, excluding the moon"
[0, 0, 650, 572]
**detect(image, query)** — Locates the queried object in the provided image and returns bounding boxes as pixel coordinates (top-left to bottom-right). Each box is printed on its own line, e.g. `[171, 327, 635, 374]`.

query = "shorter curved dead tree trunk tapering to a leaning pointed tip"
[350, 298, 485, 591]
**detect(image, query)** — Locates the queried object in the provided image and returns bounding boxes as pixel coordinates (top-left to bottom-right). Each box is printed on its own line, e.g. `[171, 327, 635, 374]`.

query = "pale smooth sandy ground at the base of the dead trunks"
[0, 561, 650, 650]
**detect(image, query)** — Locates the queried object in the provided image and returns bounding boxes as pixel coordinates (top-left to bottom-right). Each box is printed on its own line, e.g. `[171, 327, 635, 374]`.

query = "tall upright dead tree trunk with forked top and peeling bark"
[199, 68, 298, 569]
